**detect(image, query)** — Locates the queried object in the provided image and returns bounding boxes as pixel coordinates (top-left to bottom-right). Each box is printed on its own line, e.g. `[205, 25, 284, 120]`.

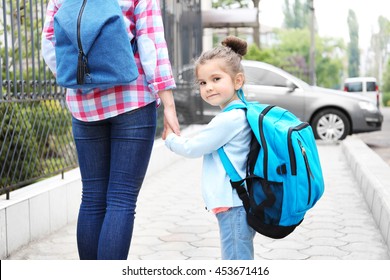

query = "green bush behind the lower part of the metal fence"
[0, 100, 77, 193]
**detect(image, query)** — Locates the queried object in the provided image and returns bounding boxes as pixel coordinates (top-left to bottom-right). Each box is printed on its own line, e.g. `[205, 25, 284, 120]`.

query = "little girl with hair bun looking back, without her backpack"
[165, 36, 255, 260]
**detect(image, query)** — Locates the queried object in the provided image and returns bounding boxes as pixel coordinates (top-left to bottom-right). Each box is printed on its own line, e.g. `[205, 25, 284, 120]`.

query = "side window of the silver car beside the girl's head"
[245, 66, 287, 87]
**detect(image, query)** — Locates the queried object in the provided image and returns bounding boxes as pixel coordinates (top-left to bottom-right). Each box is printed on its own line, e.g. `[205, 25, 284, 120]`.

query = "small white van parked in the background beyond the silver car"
[344, 77, 381, 106]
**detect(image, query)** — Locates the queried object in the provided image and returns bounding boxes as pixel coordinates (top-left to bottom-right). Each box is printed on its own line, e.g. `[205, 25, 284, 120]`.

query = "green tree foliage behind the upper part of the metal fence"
[0, 0, 52, 94]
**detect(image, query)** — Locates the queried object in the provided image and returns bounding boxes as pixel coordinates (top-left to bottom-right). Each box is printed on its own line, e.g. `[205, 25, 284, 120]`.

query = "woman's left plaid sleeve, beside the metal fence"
[41, 0, 58, 75]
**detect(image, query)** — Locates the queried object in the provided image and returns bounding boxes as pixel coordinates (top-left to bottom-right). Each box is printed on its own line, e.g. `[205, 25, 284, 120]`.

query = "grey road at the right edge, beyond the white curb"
[357, 107, 390, 165]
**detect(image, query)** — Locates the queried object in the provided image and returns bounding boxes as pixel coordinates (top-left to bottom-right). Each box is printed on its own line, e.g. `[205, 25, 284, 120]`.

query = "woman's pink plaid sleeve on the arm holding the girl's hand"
[134, 0, 176, 93]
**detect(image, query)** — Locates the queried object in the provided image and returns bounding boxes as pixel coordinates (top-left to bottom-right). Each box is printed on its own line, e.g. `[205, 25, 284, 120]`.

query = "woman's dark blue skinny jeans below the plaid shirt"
[72, 102, 157, 260]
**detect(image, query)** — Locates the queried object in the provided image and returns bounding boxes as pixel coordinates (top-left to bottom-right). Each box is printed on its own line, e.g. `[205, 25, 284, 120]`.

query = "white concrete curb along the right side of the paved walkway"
[341, 136, 390, 250]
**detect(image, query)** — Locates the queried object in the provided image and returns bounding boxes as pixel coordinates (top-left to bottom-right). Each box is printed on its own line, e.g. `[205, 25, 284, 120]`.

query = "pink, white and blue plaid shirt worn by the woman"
[42, 0, 176, 121]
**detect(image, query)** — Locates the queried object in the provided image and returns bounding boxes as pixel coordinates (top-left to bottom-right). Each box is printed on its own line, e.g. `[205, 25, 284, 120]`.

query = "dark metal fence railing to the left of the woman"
[0, 0, 77, 199]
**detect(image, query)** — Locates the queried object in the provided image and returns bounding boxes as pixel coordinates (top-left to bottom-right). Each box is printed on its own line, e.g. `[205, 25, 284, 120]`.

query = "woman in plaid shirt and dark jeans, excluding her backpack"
[42, 0, 180, 259]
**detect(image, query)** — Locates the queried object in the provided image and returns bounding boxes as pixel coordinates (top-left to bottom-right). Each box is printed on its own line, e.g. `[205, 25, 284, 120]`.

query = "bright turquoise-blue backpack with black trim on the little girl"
[218, 91, 324, 239]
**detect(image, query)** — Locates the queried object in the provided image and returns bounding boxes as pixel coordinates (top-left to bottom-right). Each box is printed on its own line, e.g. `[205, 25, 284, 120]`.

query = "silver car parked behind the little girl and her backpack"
[174, 60, 383, 140]
